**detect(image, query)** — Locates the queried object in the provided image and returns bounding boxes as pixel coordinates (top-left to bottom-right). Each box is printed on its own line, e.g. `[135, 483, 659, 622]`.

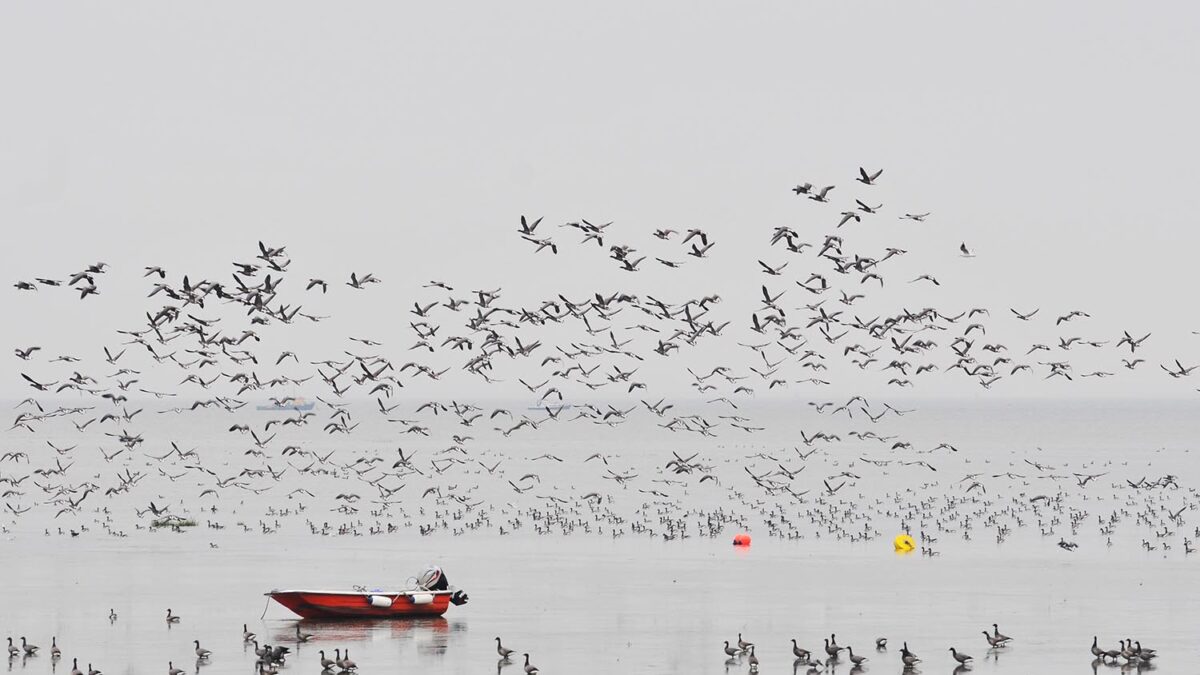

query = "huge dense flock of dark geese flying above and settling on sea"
[0, 168, 1200, 657]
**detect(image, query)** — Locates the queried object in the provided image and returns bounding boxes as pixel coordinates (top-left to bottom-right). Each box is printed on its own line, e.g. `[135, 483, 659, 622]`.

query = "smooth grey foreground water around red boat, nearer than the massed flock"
[0, 533, 1200, 674]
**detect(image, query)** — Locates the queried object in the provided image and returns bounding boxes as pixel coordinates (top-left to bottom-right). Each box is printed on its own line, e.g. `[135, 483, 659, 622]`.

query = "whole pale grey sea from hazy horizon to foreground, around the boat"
[0, 401, 1200, 675]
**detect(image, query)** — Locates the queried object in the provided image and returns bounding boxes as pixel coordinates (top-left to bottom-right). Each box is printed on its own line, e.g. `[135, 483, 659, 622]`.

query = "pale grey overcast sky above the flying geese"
[0, 0, 1200, 394]
